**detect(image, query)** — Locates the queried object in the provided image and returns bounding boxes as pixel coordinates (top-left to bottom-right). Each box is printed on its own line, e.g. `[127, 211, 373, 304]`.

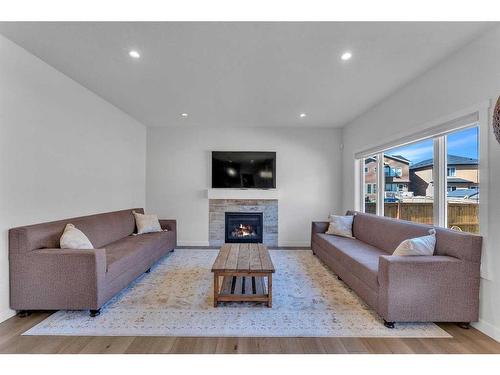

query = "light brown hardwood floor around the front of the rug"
[0, 313, 500, 354]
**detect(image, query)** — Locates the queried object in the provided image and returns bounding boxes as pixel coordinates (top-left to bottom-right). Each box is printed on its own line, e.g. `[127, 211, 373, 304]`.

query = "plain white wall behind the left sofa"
[0, 36, 146, 321]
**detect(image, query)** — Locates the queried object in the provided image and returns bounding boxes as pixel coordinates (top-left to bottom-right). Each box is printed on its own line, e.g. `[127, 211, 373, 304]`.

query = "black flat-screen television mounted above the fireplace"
[212, 151, 276, 189]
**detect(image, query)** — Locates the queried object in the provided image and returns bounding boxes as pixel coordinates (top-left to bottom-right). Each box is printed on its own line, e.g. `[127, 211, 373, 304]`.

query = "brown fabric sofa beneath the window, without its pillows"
[311, 212, 482, 328]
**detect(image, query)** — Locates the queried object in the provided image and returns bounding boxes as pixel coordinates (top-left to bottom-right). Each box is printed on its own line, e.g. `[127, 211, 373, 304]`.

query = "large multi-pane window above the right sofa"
[362, 125, 479, 233]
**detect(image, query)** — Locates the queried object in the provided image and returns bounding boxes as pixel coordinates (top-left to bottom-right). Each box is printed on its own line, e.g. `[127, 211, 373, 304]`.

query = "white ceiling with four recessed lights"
[0, 22, 491, 127]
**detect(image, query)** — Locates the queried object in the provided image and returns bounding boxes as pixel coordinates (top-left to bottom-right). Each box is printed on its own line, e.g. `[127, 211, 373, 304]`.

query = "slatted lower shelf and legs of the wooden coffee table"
[214, 273, 272, 307]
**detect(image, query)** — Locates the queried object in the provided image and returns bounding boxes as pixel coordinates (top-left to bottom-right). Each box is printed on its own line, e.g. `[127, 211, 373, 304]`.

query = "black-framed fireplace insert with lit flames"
[225, 212, 263, 243]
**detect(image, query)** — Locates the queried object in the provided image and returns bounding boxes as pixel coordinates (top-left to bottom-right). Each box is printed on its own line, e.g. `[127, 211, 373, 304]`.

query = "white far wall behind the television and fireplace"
[146, 128, 341, 246]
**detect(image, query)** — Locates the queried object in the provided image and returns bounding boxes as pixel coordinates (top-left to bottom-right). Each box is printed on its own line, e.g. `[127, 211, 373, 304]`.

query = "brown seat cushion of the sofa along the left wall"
[106, 232, 170, 280]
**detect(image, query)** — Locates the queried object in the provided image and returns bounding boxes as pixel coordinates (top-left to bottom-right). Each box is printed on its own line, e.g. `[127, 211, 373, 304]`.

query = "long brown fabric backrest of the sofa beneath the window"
[348, 211, 482, 263]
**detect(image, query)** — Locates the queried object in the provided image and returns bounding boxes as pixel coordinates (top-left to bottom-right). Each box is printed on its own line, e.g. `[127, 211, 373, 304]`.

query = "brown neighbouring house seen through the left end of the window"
[365, 155, 410, 202]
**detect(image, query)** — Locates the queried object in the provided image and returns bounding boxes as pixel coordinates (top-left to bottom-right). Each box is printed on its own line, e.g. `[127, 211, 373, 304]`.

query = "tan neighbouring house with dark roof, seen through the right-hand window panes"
[410, 155, 479, 197]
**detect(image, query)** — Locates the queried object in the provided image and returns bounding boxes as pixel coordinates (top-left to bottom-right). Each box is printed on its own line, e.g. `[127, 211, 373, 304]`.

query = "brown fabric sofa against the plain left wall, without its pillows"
[9, 208, 177, 316]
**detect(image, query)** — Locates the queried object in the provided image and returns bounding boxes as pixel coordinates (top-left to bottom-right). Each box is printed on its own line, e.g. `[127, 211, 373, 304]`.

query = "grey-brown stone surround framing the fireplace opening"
[208, 199, 278, 247]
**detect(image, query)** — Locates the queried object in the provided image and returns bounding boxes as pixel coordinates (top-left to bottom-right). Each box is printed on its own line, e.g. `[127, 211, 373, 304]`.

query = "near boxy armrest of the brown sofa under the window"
[378, 255, 479, 322]
